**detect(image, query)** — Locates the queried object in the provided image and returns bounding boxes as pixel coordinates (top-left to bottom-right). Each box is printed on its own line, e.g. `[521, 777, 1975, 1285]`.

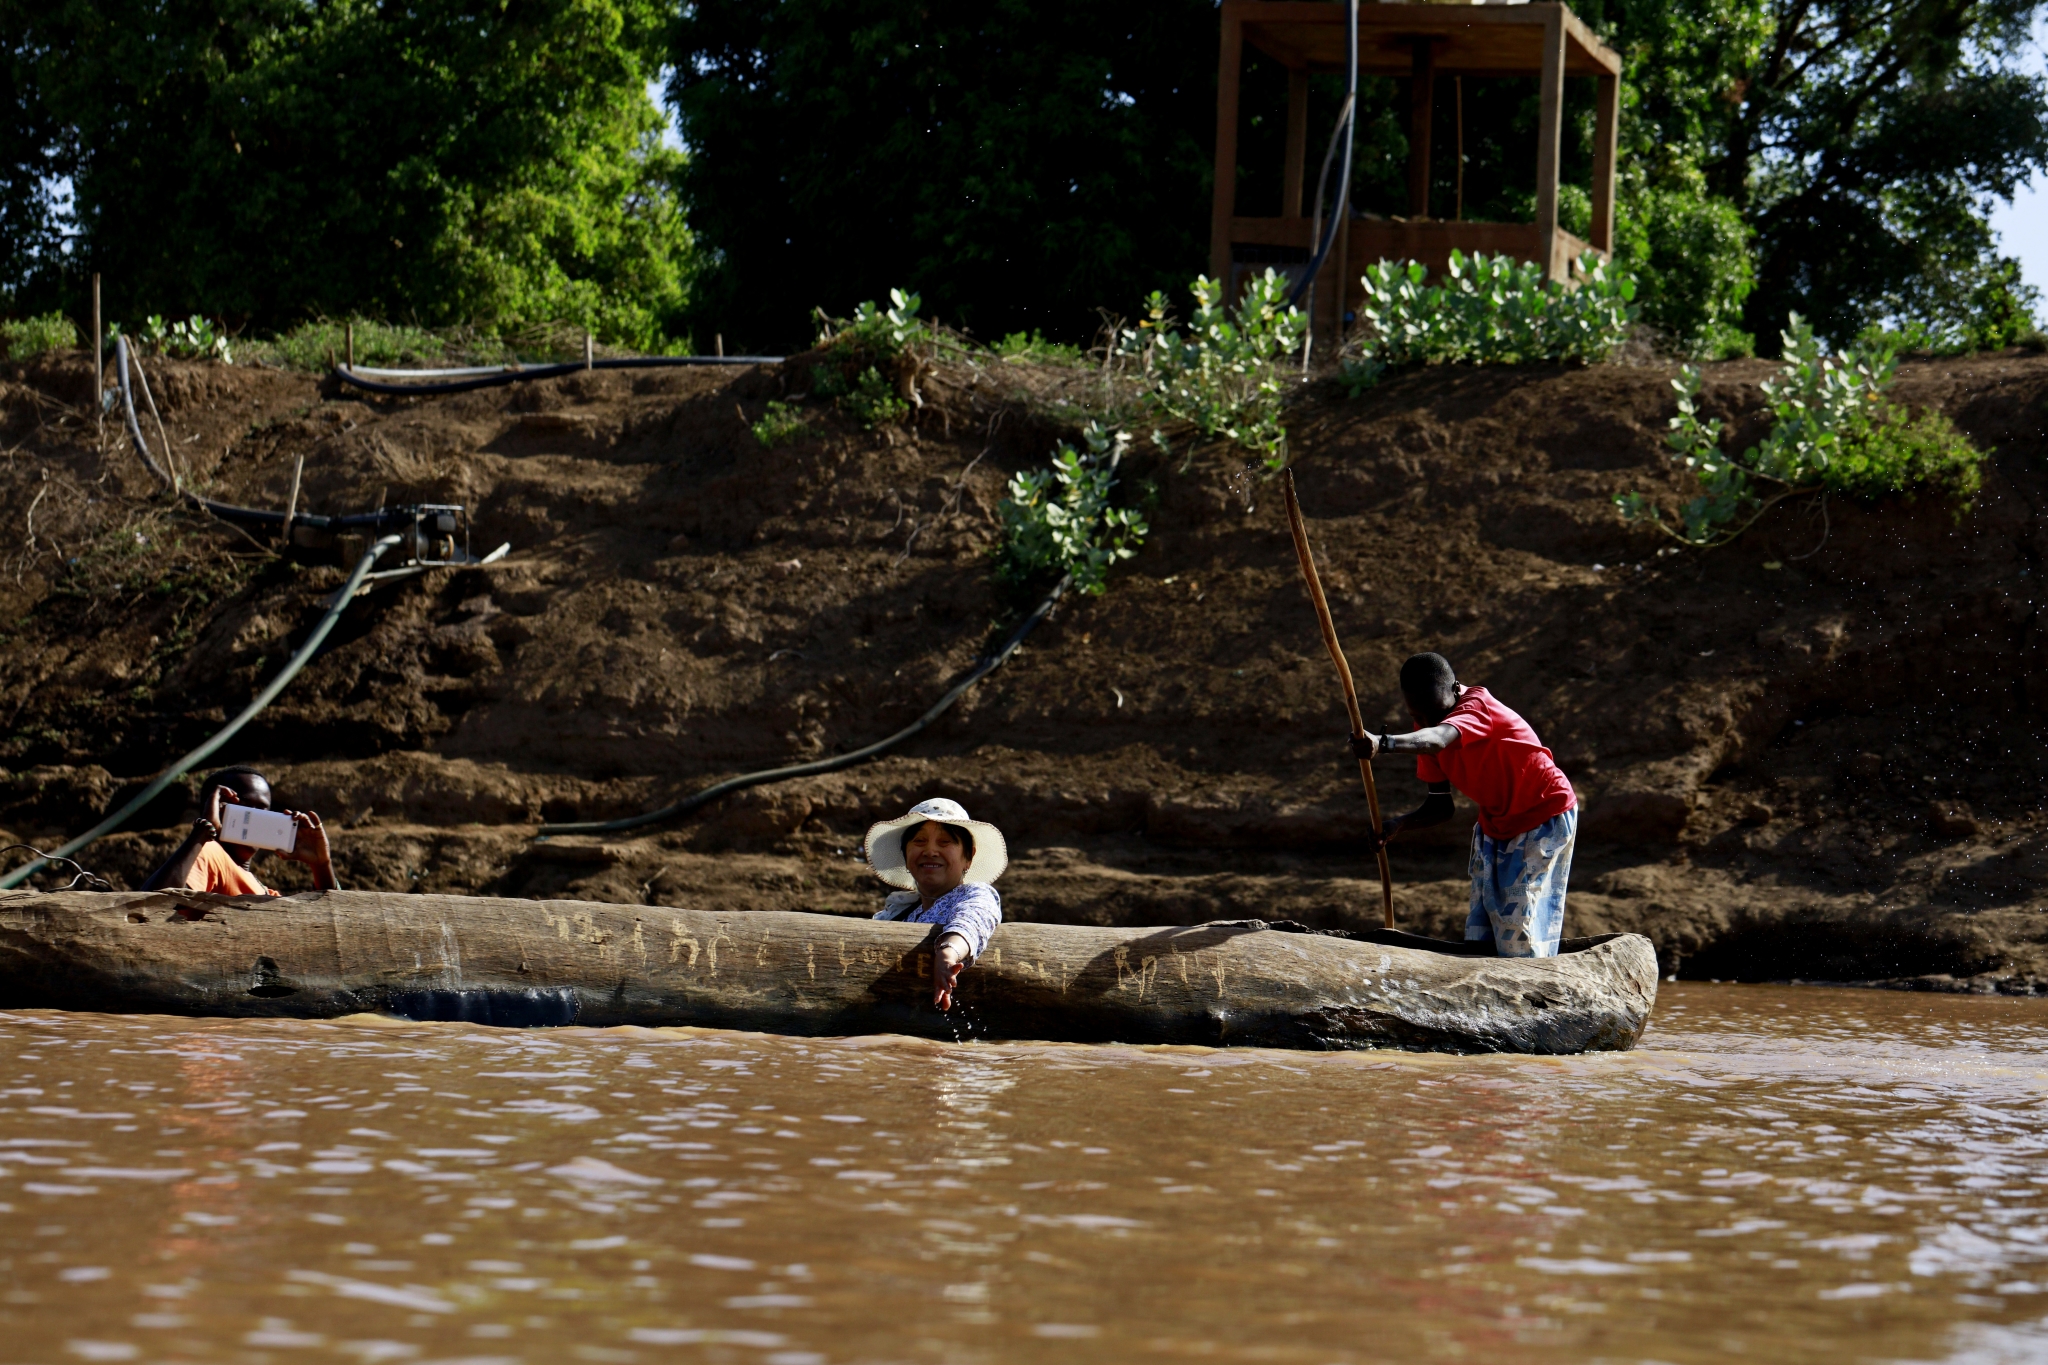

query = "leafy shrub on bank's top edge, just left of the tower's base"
[1122, 268, 1309, 469]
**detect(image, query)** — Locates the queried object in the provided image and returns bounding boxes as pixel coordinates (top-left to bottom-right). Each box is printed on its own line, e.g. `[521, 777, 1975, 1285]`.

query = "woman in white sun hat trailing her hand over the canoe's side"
[866, 796, 1010, 1009]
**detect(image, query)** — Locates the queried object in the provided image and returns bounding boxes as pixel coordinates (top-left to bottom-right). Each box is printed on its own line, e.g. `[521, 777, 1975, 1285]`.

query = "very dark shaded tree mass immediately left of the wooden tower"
[672, 0, 1217, 358]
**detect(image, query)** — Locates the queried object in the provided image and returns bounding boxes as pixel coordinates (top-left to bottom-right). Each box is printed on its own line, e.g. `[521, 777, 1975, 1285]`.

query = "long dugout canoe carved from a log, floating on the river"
[0, 890, 1657, 1054]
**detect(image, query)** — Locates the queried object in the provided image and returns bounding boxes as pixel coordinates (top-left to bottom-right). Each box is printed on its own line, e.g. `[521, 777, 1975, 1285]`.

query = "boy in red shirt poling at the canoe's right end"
[1352, 655, 1579, 958]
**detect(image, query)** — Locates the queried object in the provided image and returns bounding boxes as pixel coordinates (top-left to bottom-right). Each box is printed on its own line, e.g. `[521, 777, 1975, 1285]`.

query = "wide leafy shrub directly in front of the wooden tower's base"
[1341, 252, 1636, 395]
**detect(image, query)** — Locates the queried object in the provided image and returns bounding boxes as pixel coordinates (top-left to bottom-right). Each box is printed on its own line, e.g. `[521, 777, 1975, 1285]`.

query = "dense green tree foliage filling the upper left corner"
[0, 0, 690, 344]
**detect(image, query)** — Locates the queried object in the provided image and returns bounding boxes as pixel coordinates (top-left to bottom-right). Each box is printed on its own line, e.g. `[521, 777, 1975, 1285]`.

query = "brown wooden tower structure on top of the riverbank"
[1208, 0, 1622, 319]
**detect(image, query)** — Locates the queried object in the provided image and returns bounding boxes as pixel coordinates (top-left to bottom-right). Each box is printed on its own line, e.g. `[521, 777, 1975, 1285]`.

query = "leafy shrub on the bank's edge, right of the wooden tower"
[1614, 313, 1985, 546]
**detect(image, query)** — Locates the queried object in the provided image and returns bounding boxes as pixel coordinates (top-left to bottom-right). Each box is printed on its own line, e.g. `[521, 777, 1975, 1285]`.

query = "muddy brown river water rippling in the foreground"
[0, 984, 2048, 1365]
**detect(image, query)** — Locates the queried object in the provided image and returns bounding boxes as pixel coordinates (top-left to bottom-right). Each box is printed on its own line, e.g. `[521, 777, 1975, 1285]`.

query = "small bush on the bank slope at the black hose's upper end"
[995, 422, 1151, 596]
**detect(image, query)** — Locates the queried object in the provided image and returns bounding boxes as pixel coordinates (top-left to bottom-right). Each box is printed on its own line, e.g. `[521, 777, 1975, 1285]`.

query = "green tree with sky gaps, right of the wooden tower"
[1581, 0, 2048, 346]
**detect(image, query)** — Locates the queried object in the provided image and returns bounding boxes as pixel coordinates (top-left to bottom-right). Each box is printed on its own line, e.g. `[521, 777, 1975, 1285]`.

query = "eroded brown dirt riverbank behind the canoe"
[0, 339, 2048, 990]
